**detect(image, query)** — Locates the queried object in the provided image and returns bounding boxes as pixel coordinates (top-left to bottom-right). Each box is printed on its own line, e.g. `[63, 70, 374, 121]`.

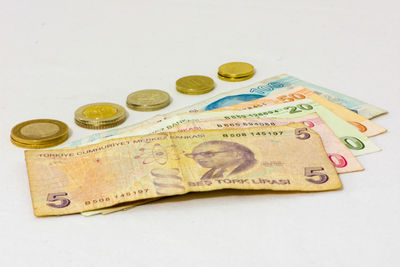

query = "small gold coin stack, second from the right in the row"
[176, 75, 214, 95]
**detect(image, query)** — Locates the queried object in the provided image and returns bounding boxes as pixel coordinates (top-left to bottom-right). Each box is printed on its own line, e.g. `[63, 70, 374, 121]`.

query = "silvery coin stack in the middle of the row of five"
[126, 89, 171, 111]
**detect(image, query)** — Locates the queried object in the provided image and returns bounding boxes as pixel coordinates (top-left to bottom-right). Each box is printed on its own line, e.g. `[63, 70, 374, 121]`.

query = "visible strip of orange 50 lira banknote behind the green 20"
[214, 86, 386, 137]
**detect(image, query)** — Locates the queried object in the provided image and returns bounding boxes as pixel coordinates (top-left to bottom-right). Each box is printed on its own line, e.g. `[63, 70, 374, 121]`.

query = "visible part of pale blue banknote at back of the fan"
[61, 74, 387, 150]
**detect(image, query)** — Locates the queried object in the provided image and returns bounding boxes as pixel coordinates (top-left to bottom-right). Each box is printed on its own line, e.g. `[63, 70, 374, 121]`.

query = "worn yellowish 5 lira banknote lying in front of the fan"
[25, 123, 341, 216]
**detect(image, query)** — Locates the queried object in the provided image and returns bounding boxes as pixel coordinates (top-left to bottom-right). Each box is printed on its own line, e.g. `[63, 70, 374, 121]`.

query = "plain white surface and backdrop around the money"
[0, 0, 400, 266]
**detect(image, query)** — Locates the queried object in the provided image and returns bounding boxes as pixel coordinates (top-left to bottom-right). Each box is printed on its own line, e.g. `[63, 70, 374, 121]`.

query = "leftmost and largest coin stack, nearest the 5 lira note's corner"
[10, 119, 69, 149]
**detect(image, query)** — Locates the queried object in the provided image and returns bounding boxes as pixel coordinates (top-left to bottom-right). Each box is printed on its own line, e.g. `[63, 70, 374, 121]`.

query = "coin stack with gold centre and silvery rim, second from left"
[75, 103, 126, 129]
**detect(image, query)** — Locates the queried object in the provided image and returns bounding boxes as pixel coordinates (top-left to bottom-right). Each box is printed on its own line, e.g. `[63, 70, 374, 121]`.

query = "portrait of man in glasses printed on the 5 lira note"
[185, 140, 257, 179]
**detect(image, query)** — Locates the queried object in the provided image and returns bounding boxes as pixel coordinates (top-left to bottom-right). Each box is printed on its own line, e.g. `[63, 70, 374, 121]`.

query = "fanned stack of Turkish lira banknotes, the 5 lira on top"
[25, 74, 386, 216]
